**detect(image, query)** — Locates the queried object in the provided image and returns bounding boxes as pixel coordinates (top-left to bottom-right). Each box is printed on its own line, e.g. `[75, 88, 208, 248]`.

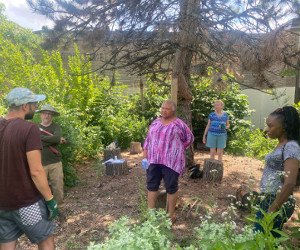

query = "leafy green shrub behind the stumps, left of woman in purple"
[87, 80, 148, 149]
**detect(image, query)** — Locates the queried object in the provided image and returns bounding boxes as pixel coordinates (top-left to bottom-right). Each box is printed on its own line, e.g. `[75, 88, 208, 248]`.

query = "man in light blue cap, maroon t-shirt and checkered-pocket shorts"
[0, 88, 58, 249]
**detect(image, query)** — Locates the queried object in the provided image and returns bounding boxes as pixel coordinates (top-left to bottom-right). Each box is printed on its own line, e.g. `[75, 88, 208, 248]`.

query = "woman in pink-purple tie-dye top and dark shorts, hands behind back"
[143, 100, 194, 222]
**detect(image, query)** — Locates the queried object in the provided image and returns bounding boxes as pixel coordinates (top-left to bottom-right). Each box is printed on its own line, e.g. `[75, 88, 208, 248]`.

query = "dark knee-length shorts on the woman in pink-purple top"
[147, 164, 179, 194]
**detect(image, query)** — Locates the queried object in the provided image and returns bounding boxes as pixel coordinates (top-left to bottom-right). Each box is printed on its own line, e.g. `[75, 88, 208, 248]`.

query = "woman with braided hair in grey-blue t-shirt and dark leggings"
[255, 106, 300, 237]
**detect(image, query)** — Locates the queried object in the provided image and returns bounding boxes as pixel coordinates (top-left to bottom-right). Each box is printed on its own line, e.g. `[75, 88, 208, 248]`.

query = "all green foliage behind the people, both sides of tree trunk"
[0, 8, 274, 186]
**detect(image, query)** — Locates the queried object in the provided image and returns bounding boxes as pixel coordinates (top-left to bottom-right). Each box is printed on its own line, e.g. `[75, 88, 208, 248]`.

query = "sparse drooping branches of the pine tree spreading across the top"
[28, 0, 299, 86]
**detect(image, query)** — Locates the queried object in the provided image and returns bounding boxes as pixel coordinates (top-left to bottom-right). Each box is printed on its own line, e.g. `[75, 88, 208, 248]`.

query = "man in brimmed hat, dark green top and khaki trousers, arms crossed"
[36, 104, 64, 206]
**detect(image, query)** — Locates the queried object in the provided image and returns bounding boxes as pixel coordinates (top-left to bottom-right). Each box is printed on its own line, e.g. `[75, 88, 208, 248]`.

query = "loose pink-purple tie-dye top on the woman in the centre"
[143, 118, 194, 174]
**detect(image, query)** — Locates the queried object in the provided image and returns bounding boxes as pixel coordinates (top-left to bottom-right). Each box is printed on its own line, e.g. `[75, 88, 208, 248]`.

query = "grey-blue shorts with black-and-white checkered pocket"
[0, 200, 55, 244]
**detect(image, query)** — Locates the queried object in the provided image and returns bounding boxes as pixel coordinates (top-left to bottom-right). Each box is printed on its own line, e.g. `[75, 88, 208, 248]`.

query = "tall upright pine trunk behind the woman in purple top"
[171, 0, 200, 167]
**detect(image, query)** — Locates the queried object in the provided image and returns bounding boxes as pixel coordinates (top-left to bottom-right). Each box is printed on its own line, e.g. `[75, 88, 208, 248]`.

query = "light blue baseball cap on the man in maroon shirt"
[5, 88, 46, 106]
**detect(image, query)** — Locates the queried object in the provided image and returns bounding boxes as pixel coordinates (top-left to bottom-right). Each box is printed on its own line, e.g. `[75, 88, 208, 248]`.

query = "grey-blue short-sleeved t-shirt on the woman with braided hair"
[260, 141, 300, 194]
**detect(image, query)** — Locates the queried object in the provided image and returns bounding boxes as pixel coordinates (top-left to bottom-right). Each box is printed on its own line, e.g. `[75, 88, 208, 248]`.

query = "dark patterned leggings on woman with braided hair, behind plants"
[254, 194, 295, 238]
